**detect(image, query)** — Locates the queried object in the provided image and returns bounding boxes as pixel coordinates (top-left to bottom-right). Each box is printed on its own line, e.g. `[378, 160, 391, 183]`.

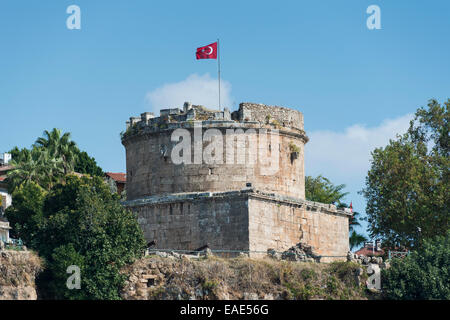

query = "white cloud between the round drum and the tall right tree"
[305, 114, 413, 184]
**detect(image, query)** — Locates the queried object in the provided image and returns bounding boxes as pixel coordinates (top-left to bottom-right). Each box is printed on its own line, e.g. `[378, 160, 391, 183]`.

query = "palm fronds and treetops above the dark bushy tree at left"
[8, 128, 103, 193]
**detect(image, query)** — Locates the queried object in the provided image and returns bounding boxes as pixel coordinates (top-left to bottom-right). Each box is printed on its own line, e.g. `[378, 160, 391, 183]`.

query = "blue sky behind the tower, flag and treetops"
[0, 0, 450, 240]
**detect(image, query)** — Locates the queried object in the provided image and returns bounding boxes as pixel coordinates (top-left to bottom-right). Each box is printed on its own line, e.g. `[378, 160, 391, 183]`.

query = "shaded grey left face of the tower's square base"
[132, 193, 248, 250]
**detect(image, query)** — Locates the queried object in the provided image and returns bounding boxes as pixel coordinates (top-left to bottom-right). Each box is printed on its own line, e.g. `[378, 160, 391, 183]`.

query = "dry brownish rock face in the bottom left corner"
[0, 250, 42, 300]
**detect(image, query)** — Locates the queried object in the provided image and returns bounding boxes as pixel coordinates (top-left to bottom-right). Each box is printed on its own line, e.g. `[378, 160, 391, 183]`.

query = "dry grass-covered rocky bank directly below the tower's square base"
[122, 256, 367, 300]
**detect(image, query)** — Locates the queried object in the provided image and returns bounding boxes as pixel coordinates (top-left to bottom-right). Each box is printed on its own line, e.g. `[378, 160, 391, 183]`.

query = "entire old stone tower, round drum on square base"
[122, 103, 350, 260]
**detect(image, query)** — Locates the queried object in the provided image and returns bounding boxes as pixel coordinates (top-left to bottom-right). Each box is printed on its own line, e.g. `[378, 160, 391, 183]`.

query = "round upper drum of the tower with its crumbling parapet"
[122, 103, 308, 200]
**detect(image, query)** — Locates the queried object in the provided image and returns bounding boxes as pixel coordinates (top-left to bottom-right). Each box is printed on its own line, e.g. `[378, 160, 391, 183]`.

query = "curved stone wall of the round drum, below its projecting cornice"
[126, 125, 305, 200]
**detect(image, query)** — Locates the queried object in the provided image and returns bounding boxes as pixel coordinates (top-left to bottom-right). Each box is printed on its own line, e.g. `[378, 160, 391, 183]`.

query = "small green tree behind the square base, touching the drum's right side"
[305, 175, 348, 204]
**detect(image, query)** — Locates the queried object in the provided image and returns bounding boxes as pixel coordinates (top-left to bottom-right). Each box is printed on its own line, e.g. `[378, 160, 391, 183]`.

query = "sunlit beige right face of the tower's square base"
[249, 197, 349, 262]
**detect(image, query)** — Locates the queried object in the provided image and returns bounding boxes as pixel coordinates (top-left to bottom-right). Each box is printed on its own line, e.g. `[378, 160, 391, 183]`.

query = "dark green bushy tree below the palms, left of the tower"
[6, 176, 145, 299]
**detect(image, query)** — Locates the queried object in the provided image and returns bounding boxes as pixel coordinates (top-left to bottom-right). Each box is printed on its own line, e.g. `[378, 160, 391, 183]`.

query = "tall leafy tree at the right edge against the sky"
[363, 100, 450, 248]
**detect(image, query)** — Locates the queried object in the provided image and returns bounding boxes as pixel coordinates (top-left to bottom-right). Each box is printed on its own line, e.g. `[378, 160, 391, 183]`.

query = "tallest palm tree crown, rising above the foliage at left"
[34, 128, 78, 174]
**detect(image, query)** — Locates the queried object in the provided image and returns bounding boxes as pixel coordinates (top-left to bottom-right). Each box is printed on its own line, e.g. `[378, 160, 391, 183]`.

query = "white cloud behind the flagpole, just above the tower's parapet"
[146, 73, 232, 114]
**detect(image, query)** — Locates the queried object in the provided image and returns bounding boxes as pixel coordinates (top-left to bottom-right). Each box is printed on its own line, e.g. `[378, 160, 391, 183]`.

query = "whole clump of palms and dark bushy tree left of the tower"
[6, 129, 141, 299]
